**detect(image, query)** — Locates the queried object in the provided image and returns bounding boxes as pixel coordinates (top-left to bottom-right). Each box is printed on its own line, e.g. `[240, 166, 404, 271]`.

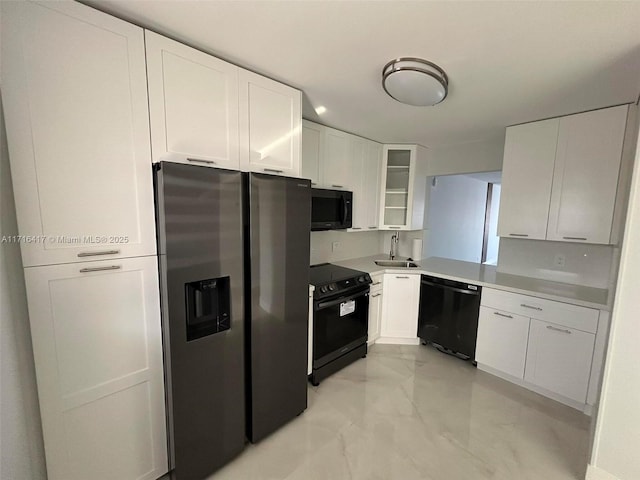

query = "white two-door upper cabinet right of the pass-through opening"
[498, 105, 631, 244]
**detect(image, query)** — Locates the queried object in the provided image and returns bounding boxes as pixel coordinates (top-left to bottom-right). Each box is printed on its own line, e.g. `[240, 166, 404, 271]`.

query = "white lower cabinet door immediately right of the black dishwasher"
[476, 307, 529, 379]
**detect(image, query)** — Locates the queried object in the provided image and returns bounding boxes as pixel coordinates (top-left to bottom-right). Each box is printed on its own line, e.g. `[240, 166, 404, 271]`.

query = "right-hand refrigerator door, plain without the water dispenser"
[244, 173, 311, 442]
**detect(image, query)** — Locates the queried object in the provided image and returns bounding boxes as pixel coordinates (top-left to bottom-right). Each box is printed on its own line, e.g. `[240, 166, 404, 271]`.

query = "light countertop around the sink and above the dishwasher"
[333, 254, 610, 310]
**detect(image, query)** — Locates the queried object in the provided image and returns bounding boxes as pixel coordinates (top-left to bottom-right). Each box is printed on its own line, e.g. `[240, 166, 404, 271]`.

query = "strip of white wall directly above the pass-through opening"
[427, 133, 504, 176]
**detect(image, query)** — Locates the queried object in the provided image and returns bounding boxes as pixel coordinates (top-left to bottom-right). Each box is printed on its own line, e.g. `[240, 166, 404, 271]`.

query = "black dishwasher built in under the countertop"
[418, 275, 482, 360]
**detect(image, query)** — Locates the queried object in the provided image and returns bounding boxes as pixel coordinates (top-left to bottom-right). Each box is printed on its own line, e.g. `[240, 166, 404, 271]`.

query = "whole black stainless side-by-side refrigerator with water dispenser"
[154, 162, 310, 480]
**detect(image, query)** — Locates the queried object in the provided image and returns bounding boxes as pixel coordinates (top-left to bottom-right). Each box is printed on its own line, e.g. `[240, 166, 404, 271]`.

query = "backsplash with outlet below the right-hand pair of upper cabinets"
[497, 238, 614, 288]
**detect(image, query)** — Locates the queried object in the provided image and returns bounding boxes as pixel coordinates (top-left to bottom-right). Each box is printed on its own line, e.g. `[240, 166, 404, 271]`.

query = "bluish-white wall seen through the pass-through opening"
[423, 175, 487, 263]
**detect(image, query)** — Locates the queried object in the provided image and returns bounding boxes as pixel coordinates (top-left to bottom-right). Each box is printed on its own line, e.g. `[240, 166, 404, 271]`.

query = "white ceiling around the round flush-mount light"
[85, 0, 640, 146]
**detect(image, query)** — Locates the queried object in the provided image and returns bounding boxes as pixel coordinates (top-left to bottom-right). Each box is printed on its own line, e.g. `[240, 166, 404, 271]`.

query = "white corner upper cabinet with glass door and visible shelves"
[379, 145, 427, 230]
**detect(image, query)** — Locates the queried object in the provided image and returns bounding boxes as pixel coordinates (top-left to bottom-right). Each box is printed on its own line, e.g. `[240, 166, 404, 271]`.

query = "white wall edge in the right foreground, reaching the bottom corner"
[587, 106, 640, 480]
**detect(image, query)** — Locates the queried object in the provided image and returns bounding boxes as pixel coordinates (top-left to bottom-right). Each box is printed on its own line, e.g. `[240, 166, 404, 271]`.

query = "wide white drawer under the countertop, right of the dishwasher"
[481, 288, 599, 333]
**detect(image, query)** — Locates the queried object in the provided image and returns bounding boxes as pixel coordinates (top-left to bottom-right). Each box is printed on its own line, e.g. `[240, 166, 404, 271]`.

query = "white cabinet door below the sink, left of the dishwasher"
[380, 273, 420, 345]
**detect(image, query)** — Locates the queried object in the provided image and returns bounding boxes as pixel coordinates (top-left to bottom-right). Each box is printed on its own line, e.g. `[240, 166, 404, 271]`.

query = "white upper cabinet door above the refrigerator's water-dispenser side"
[145, 30, 240, 170]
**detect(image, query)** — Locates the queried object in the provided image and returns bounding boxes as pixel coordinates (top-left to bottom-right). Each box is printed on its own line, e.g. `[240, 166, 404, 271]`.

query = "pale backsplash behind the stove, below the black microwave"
[310, 230, 380, 265]
